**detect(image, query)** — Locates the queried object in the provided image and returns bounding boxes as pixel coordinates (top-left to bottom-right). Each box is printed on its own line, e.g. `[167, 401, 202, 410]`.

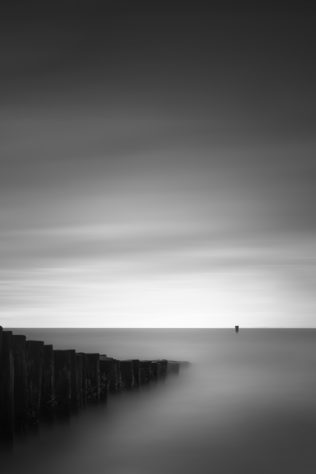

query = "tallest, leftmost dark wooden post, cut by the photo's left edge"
[0, 328, 14, 443]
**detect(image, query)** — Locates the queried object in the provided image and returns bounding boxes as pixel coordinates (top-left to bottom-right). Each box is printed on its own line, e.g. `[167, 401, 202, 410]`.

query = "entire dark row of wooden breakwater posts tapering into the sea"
[0, 327, 180, 442]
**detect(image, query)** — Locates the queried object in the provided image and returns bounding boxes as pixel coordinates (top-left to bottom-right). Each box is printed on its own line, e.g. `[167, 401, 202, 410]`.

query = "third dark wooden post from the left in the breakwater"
[26, 341, 44, 425]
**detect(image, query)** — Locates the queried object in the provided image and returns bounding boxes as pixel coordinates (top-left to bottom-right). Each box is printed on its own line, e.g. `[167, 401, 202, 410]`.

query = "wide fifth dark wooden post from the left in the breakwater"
[54, 350, 71, 415]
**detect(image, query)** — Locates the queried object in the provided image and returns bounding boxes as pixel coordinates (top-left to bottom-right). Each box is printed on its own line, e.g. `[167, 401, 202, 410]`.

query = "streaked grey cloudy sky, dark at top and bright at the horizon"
[0, 0, 316, 327]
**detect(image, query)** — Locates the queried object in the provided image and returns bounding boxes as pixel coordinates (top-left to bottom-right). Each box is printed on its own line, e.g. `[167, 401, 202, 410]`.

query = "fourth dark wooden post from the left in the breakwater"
[41, 344, 56, 417]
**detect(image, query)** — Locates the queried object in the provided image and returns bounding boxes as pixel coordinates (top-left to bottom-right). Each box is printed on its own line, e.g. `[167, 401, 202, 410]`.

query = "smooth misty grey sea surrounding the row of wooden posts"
[1, 330, 316, 474]
